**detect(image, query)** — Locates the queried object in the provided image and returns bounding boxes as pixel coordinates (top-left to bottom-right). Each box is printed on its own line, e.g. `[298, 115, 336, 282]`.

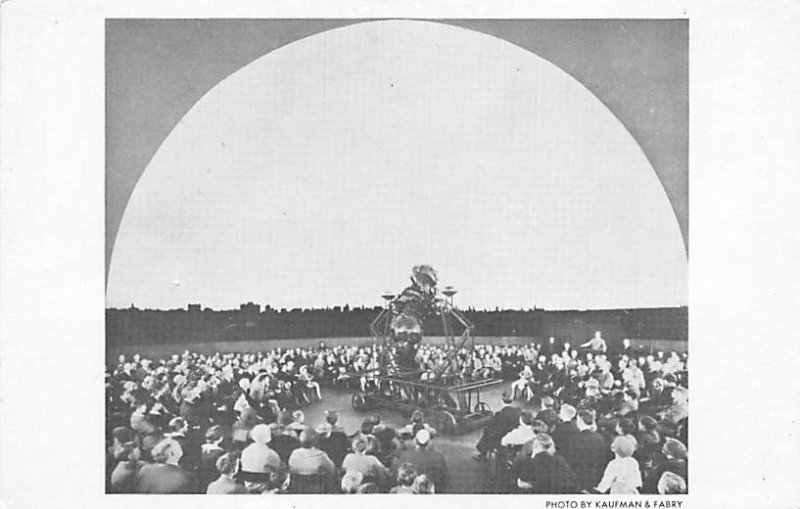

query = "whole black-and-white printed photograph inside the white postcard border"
[105, 19, 689, 495]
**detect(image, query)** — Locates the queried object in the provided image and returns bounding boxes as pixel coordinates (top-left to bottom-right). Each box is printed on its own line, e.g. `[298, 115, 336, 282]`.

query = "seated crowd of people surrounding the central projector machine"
[106, 333, 688, 494]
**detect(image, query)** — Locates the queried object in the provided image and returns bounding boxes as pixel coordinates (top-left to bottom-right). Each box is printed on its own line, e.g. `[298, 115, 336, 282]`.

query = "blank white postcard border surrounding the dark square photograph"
[0, 0, 800, 508]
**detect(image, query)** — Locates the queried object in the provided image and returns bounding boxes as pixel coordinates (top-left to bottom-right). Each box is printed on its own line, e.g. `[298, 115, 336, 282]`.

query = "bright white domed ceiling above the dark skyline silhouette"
[107, 21, 688, 309]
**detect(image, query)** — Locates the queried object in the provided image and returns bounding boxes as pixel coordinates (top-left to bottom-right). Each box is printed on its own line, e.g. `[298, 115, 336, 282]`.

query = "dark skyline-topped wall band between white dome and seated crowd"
[106, 304, 688, 346]
